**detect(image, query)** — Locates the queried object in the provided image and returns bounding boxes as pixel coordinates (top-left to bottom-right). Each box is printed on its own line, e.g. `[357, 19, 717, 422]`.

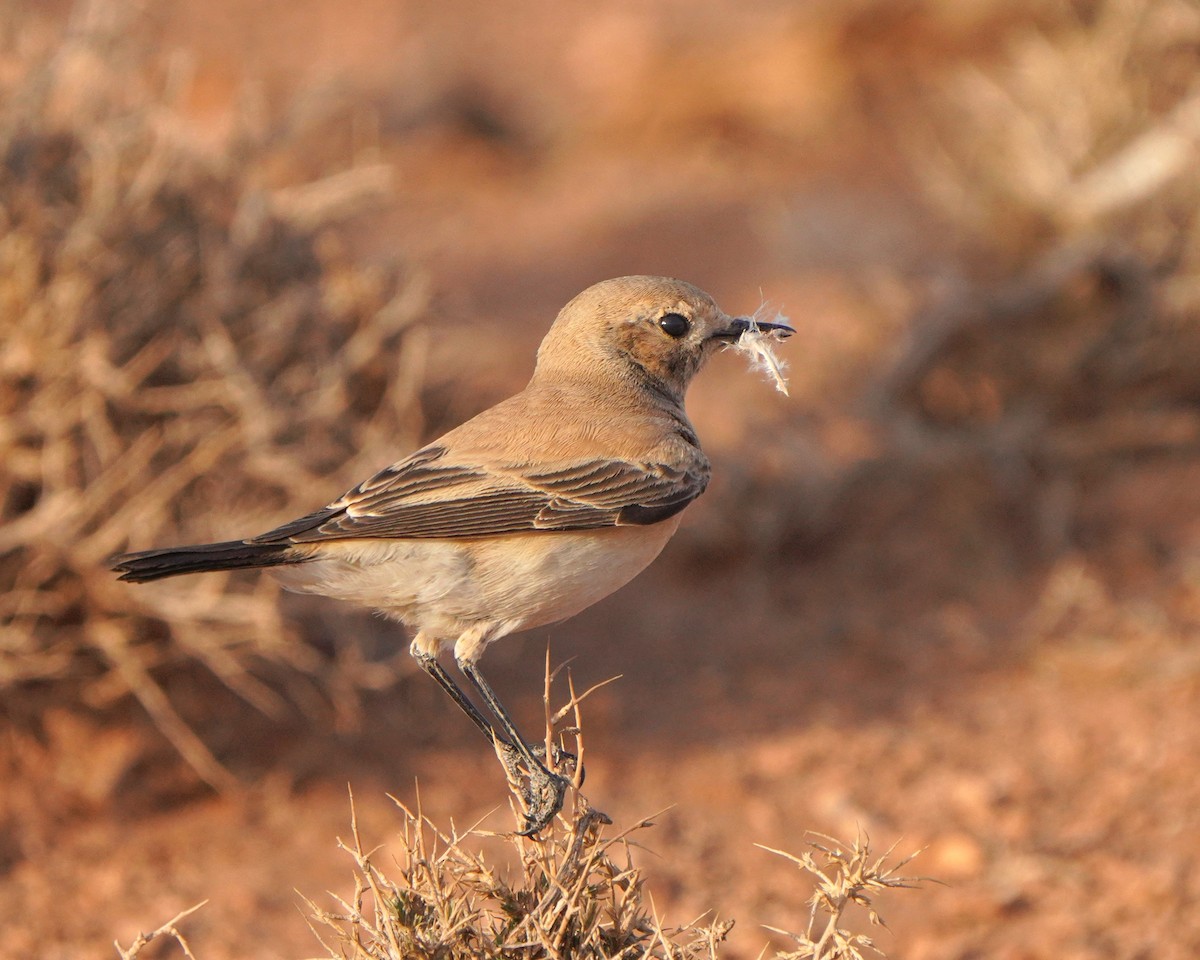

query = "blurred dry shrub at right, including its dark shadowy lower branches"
[758, 0, 1200, 564]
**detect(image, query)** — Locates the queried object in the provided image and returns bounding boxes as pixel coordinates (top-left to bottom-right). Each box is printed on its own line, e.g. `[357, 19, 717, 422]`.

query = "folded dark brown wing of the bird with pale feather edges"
[252, 446, 708, 544]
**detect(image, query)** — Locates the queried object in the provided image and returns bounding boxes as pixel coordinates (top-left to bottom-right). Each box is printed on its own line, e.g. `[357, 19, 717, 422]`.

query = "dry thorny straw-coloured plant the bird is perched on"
[300, 668, 733, 960]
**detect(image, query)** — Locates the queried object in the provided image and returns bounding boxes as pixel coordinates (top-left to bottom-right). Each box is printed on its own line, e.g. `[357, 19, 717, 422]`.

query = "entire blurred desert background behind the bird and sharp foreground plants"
[0, 0, 1200, 960]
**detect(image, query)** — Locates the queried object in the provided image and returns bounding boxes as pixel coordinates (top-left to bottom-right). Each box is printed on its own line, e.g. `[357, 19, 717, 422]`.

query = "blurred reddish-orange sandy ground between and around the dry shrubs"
[0, 0, 1200, 960]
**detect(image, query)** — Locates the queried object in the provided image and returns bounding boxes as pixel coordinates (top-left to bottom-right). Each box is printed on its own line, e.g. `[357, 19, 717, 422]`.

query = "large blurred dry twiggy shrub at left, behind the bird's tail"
[0, 5, 424, 782]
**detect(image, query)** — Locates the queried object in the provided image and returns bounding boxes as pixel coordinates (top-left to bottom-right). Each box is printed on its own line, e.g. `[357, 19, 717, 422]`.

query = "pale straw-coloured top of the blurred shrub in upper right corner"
[911, 0, 1200, 253]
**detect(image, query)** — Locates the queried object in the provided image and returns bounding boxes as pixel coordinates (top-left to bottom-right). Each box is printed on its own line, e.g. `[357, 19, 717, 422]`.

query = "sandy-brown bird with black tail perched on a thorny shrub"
[113, 276, 794, 835]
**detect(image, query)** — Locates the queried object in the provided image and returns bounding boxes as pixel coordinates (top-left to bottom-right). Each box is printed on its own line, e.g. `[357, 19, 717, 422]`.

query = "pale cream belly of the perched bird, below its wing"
[272, 516, 679, 646]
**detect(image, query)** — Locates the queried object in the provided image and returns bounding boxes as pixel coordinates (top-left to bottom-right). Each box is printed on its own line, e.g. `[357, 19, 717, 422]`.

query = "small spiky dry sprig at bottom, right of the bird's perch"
[757, 833, 928, 960]
